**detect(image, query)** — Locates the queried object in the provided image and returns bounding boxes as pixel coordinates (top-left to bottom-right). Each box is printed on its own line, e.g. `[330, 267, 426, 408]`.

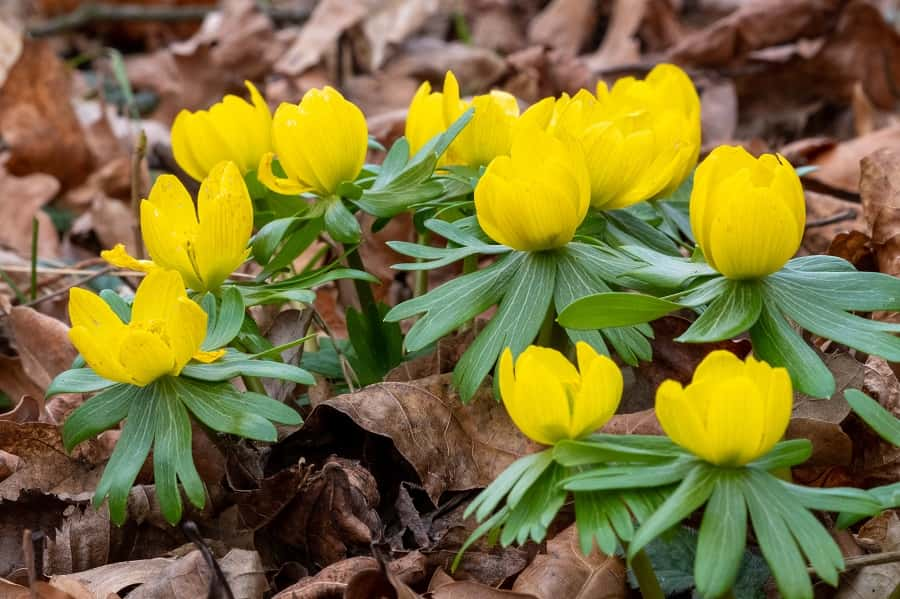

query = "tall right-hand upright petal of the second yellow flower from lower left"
[195, 162, 253, 291]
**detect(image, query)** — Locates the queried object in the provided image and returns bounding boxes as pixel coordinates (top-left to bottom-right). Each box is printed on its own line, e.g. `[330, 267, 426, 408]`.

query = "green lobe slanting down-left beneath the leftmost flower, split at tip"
[94, 381, 160, 525]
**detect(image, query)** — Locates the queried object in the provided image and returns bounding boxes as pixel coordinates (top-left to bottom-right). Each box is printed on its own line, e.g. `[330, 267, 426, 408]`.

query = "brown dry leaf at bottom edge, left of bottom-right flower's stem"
[513, 524, 628, 599]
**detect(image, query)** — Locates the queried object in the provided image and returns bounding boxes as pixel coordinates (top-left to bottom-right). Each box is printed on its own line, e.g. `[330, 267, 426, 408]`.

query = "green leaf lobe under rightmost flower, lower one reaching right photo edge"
[766, 279, 900, 362]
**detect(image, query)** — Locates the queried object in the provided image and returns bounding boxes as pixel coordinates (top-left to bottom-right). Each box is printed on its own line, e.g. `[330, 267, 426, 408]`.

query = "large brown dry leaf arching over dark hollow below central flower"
[299, 375, 535, 503]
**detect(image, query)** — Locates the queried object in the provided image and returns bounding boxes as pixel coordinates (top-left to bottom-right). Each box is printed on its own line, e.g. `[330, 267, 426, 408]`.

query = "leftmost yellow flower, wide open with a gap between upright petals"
[69, 269, 224, 387]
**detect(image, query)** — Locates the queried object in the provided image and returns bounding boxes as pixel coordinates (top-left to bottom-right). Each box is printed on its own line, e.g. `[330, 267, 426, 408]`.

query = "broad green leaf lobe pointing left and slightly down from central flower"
[384, 252, 525, 351]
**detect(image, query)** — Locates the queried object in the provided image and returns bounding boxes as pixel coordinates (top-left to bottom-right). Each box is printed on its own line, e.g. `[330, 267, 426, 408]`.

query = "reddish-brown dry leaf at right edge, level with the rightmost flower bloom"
[860, 146, 900, 276]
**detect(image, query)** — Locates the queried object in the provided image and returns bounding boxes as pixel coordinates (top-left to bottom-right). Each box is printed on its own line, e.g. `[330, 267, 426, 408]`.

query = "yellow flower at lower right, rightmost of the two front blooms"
[656, 350, 792, 466]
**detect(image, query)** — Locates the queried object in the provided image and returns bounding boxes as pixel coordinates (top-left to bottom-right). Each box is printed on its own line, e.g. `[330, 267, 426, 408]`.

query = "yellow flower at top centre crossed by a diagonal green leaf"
[405, 71, 519, 167]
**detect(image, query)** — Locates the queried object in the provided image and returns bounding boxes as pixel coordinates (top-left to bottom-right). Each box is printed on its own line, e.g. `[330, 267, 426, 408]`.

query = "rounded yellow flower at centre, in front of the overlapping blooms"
[475, 129, 590, 251]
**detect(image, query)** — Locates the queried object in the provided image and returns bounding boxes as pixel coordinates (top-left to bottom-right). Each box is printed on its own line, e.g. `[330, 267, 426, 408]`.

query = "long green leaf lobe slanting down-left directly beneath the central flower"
[453, 253, 556, 400]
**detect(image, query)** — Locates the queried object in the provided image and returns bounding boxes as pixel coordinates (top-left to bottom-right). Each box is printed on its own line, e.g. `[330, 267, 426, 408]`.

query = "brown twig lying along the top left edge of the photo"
[28, 2, 311, 37]
